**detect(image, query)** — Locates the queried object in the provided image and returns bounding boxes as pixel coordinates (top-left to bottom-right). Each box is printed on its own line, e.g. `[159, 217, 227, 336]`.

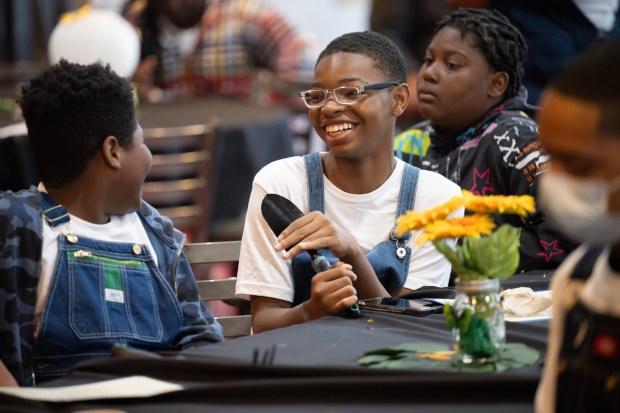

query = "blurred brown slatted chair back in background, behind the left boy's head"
[142, 118, 218, 242]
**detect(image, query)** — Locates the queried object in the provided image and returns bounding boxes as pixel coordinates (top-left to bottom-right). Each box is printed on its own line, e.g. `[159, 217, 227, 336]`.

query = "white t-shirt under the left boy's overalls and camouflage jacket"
[35, 212, 157, 335]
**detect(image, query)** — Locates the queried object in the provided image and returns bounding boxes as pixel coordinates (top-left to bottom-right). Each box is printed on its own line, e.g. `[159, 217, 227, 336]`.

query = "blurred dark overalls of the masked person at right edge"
[556, 247, 620, 412]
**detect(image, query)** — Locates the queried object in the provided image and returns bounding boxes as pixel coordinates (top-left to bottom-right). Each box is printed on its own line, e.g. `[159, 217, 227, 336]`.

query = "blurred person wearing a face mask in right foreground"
[536, 39, 620, 413]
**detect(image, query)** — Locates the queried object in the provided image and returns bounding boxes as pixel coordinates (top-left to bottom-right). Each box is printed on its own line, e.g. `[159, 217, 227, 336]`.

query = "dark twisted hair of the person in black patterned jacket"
[434, 8, 527, 98]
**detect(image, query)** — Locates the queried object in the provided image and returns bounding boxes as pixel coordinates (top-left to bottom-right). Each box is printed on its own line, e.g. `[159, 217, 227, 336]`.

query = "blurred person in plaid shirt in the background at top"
[126, 0, 315, 104]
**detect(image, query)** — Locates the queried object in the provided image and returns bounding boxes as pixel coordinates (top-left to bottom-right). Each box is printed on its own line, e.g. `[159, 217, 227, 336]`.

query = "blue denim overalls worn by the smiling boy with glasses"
[291, 152, 420, 306]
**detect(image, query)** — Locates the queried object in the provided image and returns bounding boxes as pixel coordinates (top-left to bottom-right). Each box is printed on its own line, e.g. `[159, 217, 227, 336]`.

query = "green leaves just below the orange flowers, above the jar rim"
[433, 224, 521, 281]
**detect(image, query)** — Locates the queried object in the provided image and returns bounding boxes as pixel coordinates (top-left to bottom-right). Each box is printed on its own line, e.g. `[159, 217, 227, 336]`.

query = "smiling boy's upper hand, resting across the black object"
[275, 211, 359, 262]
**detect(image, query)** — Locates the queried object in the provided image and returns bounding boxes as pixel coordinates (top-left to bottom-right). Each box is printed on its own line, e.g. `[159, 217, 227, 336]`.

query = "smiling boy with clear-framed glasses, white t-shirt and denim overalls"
[237, 32, 462, 332]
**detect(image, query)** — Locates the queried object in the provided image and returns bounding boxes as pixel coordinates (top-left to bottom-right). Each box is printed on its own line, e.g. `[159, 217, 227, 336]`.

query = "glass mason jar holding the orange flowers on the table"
[452, 278, 506, 364]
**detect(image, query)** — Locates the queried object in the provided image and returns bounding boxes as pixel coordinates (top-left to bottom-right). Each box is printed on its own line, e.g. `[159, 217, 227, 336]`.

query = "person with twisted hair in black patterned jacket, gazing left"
[394, 9, 576, 272]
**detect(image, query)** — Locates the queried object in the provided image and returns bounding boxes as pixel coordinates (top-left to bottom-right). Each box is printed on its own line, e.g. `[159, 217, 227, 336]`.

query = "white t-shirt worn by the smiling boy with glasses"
[237, 157, 463, 302]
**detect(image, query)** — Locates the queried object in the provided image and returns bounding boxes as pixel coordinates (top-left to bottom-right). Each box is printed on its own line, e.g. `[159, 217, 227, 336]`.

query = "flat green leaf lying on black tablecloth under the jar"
[357, 343, 540, 373]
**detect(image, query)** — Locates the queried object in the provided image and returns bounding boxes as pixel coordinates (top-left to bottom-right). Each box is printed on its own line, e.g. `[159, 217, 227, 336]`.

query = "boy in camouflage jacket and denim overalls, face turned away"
[0, 60, 222, 386]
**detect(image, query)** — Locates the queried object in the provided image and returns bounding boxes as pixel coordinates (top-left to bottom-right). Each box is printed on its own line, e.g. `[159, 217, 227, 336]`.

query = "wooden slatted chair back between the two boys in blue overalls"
[184, 241, 252, 337]
